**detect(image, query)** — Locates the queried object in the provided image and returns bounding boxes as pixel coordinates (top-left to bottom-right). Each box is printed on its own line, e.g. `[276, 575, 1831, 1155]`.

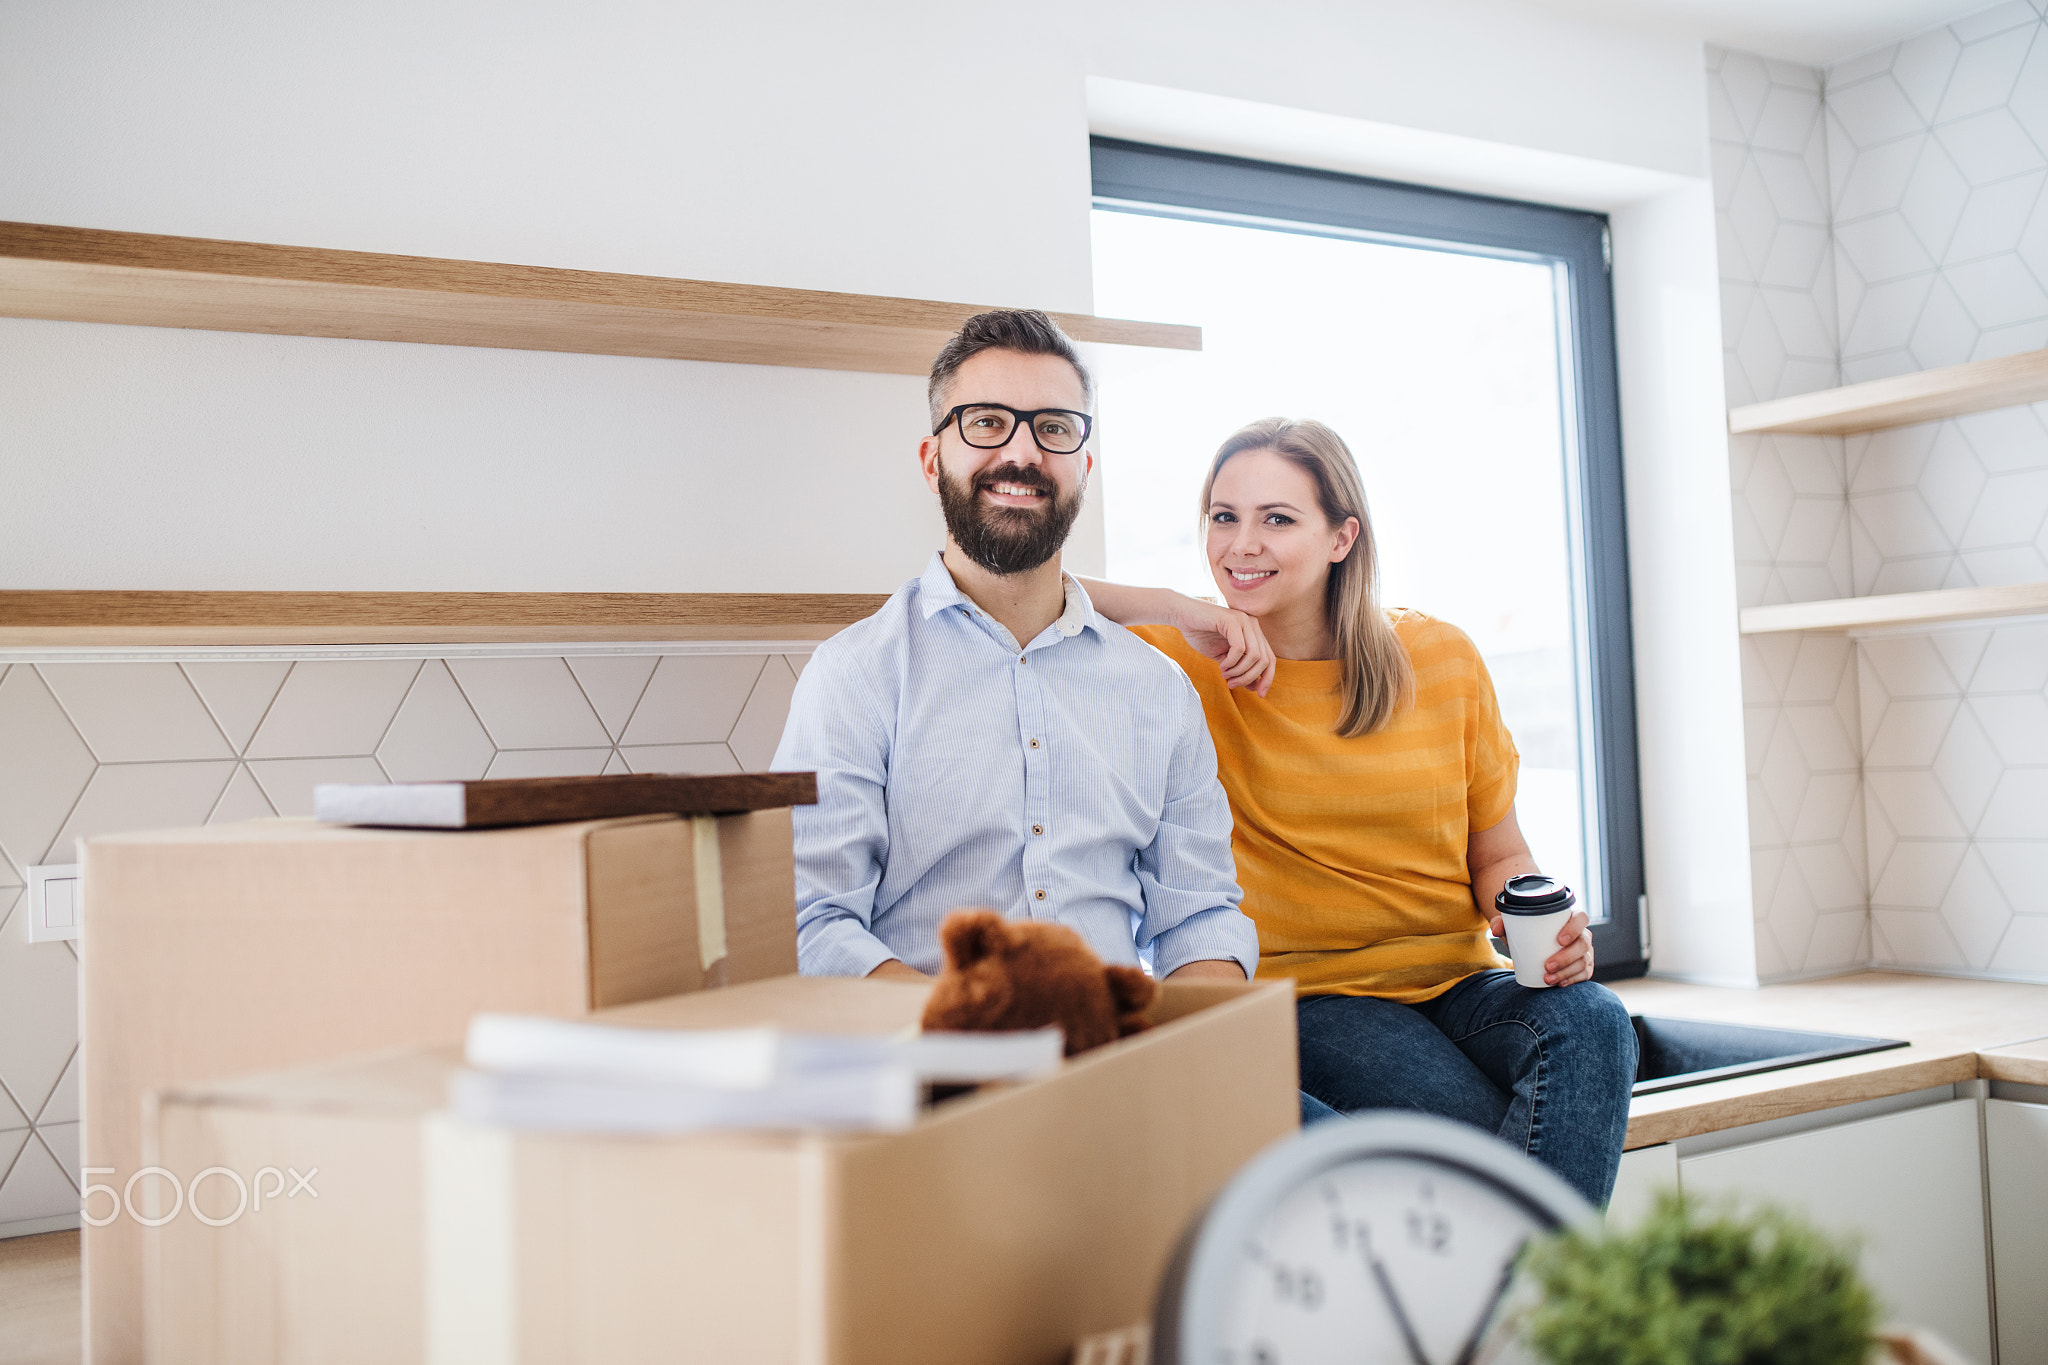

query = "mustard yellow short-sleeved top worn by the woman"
[1137, 610, 1520, 1003]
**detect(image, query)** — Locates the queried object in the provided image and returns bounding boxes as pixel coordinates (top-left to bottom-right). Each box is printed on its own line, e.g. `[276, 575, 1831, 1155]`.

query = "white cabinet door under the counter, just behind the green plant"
[1677, 1099, 1982, 1365]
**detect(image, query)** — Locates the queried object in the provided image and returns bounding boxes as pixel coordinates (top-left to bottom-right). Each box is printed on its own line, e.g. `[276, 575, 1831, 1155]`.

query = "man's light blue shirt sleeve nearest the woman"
[1137, 677, 1260, 978]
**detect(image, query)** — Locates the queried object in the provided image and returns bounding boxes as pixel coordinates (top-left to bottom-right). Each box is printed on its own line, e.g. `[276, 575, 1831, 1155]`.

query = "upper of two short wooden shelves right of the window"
[1729, 350, 2048, 436]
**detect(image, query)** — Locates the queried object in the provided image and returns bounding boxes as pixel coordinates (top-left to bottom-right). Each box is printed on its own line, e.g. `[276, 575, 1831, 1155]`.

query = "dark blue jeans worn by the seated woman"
[1296, 970, 1636, 1205]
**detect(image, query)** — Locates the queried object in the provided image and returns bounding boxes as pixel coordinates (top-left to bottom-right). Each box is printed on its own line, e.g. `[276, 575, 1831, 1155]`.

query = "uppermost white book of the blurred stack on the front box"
[465, 1015, 1065, 1091]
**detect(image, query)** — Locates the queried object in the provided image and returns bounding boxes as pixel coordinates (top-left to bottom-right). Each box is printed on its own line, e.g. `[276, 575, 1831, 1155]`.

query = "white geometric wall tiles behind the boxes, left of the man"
[0, 647, 805, 1236]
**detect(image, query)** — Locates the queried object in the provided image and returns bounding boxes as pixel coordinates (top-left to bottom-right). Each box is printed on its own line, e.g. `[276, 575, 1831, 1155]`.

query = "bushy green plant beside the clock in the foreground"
[1522, 1193, 1875, 1365]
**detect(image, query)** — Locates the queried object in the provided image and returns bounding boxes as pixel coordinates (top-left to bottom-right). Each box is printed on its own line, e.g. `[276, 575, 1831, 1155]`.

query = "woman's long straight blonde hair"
[1202, 417, 1415, 739]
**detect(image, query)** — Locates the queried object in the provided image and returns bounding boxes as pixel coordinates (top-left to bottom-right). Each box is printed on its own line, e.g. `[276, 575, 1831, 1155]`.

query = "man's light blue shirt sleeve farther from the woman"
[774, 649, 897, 976]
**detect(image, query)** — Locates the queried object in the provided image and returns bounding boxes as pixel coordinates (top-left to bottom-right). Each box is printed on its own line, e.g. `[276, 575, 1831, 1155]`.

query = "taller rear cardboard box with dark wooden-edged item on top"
[80, 808, 797, 1365]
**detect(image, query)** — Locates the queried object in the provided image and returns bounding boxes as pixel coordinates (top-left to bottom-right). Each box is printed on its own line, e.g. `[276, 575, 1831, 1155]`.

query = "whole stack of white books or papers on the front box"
[449, 1015, 1065, 1134]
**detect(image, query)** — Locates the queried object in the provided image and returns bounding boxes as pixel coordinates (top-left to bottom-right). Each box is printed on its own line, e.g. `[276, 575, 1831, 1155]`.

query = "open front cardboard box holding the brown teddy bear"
[150, 976, 1298, 1365]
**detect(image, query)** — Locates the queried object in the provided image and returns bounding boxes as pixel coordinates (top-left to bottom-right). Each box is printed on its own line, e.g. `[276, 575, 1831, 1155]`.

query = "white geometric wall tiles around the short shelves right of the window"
[1708, 13, 2048, 994]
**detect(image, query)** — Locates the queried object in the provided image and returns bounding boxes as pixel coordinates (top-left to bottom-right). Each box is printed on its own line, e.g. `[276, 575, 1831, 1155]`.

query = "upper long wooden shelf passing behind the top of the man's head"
[0, 223, 1202, 375]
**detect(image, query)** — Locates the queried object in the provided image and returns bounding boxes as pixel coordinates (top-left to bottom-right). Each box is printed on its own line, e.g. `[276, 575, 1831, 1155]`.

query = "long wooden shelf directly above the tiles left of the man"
[0, 591, 887, 649]
